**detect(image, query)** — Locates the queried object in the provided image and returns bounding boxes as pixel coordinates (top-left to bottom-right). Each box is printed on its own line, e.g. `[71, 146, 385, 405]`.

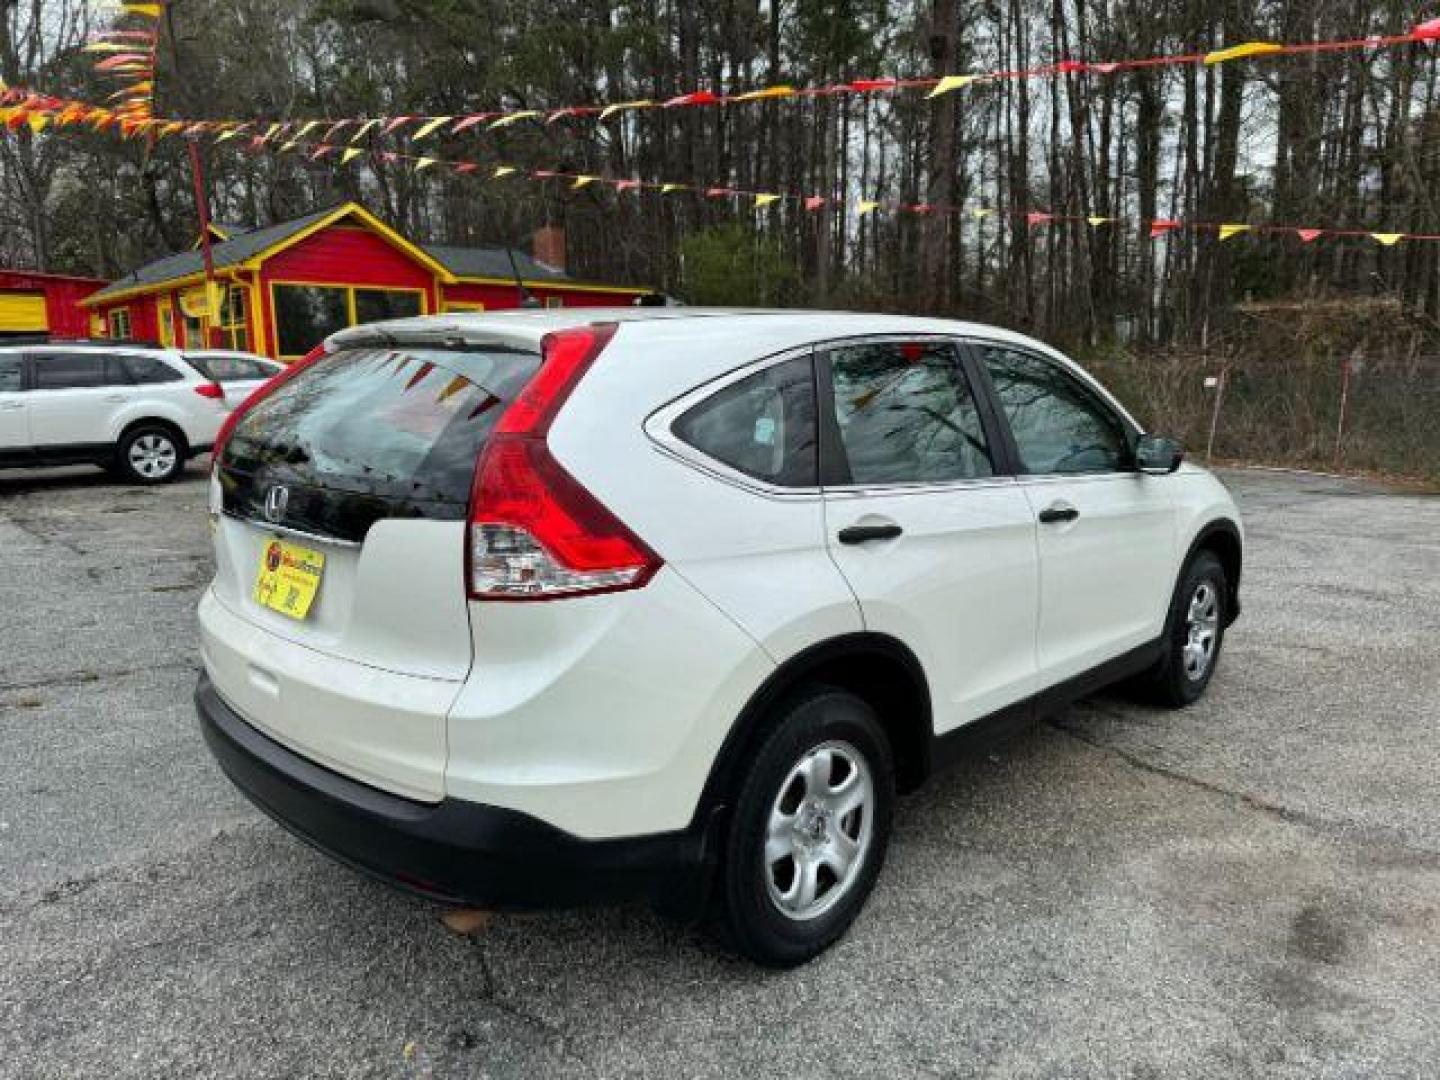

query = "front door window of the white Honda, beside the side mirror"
[981, 346, 1130, 475]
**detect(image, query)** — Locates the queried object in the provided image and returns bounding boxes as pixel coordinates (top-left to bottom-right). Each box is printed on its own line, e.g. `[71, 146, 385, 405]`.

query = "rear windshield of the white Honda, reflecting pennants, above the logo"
[220, 347, 540, 541]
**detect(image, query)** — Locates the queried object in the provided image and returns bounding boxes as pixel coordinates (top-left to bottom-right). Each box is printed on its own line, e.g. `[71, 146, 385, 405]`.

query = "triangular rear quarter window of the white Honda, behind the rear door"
[674, 356, 818, 488]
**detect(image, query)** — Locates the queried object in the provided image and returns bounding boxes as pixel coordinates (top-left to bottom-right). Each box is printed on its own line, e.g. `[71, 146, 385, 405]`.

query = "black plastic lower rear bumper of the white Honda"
[194, 675, 719, 917]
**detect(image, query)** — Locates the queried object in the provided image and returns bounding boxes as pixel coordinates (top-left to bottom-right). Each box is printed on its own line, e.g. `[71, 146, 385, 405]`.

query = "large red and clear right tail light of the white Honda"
[468, 324, 661, 600]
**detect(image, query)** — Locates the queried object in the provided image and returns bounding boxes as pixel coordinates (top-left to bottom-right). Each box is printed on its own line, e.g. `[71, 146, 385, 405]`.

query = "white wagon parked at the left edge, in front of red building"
[0, 341, 232, 484]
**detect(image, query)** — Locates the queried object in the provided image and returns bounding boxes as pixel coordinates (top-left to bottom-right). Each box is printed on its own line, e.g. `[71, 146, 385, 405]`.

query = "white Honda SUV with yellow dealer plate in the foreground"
[197, 310, 1241, 965]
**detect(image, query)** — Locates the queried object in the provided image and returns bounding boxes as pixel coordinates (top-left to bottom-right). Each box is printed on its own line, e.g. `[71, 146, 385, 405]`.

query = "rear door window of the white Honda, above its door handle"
[828, 341, 995, 484]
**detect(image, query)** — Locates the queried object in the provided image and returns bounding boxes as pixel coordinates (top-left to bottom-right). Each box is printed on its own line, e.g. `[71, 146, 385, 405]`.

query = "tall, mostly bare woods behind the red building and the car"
[0, 0, 1440, 472]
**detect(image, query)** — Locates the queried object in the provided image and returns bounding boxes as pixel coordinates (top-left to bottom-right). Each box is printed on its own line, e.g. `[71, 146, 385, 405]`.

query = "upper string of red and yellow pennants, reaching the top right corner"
[50, 15, 1440, 145]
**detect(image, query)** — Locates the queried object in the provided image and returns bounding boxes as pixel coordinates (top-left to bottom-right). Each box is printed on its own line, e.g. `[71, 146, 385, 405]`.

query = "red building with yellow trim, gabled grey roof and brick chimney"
[84, 203, 652, 360]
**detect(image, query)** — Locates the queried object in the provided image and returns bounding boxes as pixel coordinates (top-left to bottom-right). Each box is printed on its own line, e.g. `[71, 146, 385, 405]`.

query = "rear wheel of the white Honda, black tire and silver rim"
[711, 687, 894, 968]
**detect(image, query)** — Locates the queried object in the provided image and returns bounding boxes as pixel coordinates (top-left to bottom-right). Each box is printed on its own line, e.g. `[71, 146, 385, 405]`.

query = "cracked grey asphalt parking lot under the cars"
[0, 467, 1440, 1077]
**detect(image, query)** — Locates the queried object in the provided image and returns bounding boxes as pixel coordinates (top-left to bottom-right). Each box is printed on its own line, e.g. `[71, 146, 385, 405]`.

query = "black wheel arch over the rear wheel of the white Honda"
[696, 632, 935, 821]
